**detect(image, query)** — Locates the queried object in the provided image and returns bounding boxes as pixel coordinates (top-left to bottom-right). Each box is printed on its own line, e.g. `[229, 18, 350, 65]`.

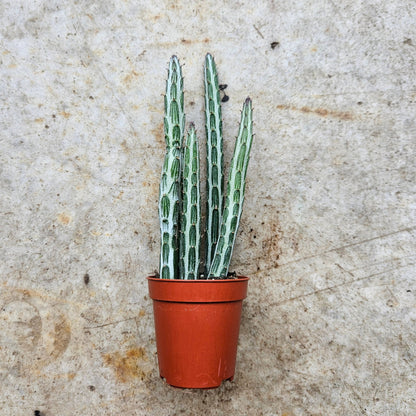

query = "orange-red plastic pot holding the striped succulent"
[148, 277, 249, 389]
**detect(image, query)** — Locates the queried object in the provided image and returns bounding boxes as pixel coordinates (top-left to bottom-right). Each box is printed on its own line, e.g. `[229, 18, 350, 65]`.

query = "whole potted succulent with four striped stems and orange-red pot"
[148, 54, 253, 388]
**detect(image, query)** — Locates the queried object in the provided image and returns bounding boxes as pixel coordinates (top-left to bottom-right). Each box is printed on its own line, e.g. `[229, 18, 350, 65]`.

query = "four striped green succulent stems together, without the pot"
[159, 54, 253, 279]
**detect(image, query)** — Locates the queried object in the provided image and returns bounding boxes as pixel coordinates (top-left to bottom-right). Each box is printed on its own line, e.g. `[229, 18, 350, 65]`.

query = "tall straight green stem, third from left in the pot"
[204, 54, 224, 273]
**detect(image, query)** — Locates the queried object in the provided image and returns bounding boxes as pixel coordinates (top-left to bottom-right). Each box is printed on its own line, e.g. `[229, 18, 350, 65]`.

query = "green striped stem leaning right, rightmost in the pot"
[209, 98, 253, 277]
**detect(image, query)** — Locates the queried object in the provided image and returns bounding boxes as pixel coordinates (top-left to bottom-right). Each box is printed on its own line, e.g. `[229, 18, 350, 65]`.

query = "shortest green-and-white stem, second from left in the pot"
[179, 124, 201, 279]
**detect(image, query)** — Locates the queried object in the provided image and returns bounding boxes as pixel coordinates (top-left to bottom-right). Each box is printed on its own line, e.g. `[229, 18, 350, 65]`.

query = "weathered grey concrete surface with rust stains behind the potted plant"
[0, 0, 416, 416]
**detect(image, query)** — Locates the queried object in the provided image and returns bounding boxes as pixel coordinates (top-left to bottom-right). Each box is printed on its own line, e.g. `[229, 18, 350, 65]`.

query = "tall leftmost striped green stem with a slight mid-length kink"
[159, 56, 185, 279]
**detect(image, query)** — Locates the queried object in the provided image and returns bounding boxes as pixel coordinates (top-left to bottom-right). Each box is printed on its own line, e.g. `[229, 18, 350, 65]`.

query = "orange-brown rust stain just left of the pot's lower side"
[102, 347, 147, 383]
